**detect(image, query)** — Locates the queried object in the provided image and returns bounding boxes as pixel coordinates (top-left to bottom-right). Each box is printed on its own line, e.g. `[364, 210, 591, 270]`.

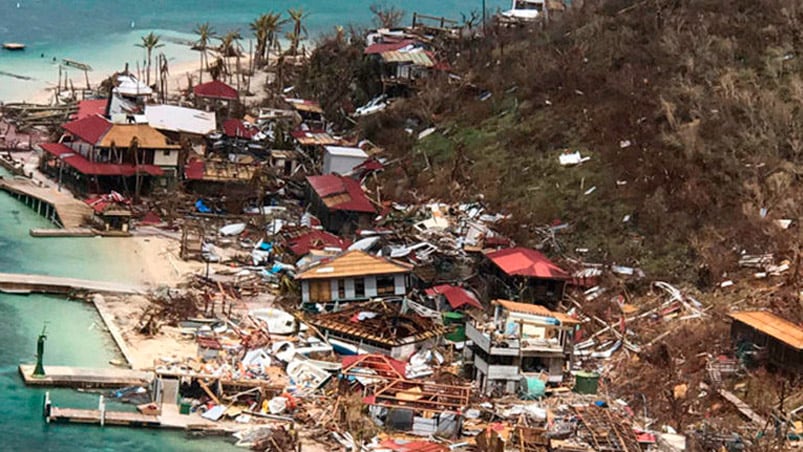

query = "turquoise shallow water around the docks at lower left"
[0, 170, 238, 451]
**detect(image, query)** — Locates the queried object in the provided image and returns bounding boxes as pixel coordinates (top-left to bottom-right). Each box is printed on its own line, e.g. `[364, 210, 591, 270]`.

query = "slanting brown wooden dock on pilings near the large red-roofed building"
[0, 177, 92, 229]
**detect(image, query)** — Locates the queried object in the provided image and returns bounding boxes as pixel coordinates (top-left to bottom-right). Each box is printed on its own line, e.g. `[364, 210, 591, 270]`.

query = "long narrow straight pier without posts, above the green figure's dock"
[0, 273, 146, 294]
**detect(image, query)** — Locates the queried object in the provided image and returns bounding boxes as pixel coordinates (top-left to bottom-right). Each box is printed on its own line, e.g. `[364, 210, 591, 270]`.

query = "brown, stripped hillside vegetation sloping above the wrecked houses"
[300, 0, 803, 294]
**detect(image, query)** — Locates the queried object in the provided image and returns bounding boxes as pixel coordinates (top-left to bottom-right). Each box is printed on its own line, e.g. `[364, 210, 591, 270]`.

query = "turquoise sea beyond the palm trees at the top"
[0, 0, 510, 102]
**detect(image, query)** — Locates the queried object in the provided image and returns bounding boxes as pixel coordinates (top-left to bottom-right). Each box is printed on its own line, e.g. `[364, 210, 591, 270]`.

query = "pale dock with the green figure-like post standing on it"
[19, 364, 153, 388]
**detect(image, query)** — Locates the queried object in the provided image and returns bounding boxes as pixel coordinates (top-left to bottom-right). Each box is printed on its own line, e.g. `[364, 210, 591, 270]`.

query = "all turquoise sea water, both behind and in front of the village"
[0, 0, 509, 451]
